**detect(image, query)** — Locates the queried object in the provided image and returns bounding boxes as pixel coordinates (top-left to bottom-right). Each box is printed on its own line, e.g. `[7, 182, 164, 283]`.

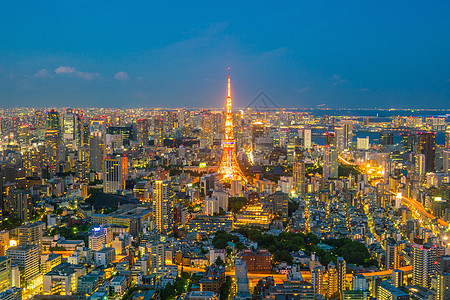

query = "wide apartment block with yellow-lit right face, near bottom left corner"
[6, 245, 39, 281]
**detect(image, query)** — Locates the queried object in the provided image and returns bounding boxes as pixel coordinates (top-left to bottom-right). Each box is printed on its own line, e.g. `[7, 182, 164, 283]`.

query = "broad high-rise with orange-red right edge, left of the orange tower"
[103, 155, 128, 193]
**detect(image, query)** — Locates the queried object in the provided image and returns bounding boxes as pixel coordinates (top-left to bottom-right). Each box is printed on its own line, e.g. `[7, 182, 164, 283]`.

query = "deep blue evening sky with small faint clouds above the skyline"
[0, 0, 450, 108]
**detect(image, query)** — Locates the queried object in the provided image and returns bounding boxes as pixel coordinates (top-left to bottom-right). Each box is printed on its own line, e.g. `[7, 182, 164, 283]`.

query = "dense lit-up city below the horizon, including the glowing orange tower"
[0, 69, 450, 300]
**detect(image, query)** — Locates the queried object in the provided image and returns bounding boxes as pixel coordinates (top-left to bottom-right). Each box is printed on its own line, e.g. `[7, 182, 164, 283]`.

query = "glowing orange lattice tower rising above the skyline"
[217, 68, 247, 181]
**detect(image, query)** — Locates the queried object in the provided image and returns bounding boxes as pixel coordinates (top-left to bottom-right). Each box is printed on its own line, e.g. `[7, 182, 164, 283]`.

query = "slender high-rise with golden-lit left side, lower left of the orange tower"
[153, 180, 174, 235]
